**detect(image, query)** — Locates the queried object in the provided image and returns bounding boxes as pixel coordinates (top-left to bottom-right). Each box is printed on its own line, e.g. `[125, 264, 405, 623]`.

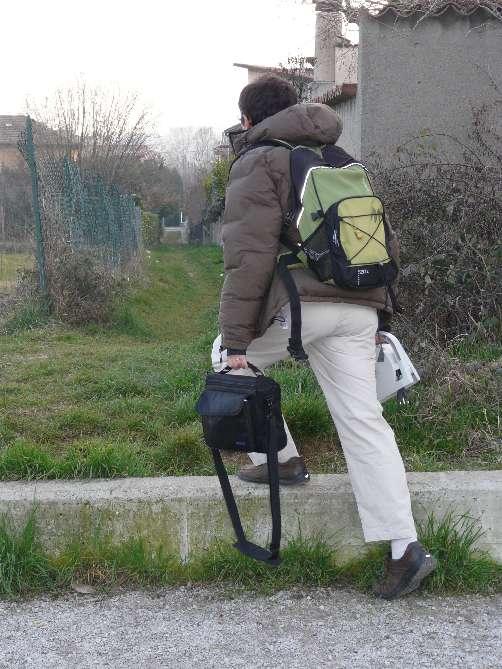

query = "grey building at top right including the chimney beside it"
[314, 0, 502, 160]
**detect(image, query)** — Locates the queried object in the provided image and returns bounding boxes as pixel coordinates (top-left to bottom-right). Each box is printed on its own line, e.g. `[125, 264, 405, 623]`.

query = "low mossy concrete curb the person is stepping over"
[0, 471, 502, 562]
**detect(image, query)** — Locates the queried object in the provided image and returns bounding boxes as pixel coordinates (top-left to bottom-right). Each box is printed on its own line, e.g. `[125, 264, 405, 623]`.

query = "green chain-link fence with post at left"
[0, 117, 141, 320]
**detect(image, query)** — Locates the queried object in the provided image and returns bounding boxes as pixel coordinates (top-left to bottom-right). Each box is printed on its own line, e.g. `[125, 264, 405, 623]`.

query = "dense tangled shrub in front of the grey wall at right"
[370, 100, 502, 357]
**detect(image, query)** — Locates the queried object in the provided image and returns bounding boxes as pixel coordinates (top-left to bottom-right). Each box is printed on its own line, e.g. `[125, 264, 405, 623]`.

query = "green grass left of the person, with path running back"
[0, 248, 222, 478]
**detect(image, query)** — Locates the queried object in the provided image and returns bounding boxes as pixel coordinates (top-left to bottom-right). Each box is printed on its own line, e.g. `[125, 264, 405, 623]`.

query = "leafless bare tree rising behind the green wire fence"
[30, 81, 183, 211]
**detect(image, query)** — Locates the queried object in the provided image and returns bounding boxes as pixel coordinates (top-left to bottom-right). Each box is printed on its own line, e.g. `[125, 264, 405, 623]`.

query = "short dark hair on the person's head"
[239, 74, 298, 125]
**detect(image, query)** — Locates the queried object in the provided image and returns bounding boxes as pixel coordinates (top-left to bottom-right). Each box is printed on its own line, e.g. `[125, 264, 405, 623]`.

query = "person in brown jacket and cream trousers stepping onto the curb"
[219, 75, 436, 599]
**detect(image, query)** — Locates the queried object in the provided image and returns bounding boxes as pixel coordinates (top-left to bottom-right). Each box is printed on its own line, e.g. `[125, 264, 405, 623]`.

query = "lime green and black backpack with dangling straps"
[235, 140, 399, 361]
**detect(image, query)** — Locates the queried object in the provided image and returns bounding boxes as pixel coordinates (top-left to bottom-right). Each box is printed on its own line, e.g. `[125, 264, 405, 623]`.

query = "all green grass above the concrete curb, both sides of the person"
[0, 247, 502, 479]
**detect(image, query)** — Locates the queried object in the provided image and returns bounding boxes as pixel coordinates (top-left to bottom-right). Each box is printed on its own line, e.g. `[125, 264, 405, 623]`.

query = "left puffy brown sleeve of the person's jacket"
[219, 149, 284, 351]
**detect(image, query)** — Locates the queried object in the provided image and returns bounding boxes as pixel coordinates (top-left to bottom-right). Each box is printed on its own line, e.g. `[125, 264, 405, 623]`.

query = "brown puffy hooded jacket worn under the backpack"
[220, 104, 397, 351]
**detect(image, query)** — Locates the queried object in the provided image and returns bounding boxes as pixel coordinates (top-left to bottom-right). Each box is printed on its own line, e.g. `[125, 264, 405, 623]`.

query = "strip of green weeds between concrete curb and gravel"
[0, 513, 502, 598]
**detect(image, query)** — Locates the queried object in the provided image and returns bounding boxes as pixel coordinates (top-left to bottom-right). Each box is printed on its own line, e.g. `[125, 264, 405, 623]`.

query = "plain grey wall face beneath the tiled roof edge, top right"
[358, 9, 502, 160]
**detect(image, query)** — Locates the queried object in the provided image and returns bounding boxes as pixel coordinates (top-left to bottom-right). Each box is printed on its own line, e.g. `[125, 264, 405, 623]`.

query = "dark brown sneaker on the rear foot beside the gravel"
[373, 541, 437, 599]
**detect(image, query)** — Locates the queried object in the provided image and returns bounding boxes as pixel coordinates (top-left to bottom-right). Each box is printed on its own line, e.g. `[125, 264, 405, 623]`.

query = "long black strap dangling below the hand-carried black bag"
[211, 417, 281, 567]
